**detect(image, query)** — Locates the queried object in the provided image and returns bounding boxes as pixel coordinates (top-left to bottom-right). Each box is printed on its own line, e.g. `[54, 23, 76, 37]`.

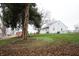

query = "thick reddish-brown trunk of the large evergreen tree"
[22, 3, 29, 40]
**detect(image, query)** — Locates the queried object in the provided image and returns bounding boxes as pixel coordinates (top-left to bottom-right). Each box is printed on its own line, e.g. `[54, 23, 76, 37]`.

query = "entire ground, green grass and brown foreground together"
[0, 33, 79, 56]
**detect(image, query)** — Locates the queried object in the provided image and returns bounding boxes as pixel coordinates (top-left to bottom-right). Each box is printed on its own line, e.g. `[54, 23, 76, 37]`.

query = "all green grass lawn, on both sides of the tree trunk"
[0, 33, 79, 46]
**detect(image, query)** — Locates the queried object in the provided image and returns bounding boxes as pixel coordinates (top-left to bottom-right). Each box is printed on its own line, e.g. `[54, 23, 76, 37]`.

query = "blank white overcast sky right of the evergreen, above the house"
[35, 0, 79, 30]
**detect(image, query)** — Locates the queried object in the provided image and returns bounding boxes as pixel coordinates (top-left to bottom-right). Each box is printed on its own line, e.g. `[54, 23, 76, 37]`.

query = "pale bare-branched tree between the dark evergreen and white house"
[38, 9, 50, 32]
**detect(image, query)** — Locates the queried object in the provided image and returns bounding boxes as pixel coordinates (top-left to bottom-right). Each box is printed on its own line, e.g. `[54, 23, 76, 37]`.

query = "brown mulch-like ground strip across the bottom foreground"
[0, 44, 79, 56]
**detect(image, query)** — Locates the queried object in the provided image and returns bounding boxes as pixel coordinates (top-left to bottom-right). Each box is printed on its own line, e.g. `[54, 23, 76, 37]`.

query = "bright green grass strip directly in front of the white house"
[32, 33, 79, 43]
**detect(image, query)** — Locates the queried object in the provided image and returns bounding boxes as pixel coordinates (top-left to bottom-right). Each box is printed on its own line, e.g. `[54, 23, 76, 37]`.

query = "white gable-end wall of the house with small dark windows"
[49, 22, 67, 33]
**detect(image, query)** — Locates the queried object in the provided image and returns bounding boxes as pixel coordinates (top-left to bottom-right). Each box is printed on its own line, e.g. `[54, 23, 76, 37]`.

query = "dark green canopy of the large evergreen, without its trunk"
[1, 3, 41, 29]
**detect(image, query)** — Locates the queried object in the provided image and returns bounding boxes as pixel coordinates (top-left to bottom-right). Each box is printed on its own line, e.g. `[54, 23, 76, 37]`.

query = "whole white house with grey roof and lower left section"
[40, 21, 68, 33]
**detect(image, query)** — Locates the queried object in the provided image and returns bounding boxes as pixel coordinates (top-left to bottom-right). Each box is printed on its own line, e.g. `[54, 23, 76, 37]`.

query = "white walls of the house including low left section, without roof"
[40, 21, 67, 33]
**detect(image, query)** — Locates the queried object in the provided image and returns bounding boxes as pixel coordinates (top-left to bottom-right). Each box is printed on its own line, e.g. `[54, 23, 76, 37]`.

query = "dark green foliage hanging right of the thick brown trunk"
[29, 3, 42, 33]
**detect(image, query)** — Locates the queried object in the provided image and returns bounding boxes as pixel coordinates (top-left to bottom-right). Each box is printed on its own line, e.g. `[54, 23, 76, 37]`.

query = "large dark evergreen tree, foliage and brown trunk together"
[1, 3, 41, 39]
